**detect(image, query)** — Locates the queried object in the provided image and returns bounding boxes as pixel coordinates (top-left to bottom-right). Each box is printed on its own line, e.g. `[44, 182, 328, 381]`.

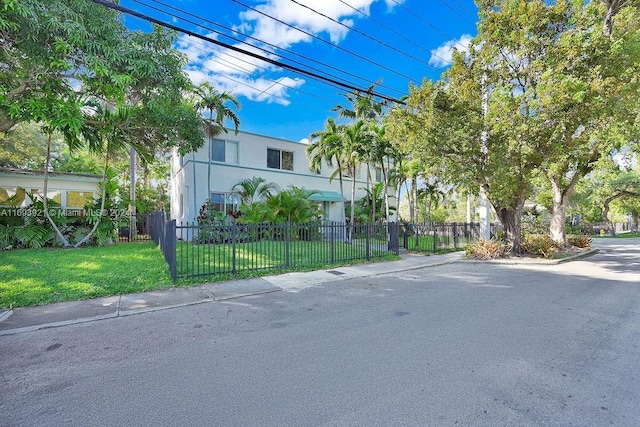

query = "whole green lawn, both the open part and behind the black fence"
[0, 241, 398, 308]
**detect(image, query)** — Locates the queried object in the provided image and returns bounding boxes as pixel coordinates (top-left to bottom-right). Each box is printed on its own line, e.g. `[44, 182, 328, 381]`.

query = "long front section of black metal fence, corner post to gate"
[176, 222, 399, 278]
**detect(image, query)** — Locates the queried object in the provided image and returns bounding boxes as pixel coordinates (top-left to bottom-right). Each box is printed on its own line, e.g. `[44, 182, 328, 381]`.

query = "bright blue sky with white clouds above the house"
[121, 0, 477, 141]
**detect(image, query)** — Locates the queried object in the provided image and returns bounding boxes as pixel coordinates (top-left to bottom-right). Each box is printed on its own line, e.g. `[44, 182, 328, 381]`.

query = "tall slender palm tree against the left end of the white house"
[195, 82, 240, 202]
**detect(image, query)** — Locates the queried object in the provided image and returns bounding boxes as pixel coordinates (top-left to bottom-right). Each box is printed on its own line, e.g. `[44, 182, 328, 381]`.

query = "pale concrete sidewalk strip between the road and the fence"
[0, 249, 598, 336]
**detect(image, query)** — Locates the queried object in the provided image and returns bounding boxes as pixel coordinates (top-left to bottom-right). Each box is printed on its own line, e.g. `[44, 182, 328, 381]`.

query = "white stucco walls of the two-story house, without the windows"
[171, 132, 392, 223]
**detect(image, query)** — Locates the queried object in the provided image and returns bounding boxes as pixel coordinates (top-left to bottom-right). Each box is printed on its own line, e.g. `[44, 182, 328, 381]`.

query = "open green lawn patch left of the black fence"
[0, 243, 172, 307]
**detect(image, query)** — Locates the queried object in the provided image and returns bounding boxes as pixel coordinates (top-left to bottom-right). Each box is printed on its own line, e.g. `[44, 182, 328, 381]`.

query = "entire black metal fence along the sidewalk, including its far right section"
[147, 212, 495, 281]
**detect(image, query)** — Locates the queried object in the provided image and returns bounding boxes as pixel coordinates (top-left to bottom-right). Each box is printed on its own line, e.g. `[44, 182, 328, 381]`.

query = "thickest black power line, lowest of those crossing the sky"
[90, 0, 405, 105]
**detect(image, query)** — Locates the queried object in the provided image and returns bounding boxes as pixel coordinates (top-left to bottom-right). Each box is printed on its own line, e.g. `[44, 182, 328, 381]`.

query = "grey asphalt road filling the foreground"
[0, 240, 640, 426]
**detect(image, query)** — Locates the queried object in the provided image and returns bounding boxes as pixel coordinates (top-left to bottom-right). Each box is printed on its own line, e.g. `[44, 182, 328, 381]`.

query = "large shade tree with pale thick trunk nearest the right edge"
[537, 2, 640, 244]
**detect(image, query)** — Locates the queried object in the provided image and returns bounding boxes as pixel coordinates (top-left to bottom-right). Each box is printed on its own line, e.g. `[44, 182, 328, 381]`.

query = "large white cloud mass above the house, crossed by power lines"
[176, 0, 404, 105]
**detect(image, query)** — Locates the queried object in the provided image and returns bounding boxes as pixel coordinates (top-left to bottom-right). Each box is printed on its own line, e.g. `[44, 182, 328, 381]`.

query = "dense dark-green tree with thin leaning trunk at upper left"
[0, 0, 203, 246]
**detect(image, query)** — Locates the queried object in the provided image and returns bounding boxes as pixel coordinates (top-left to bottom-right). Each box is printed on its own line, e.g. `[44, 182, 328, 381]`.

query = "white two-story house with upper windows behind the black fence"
[171, 131, 392, 223]
